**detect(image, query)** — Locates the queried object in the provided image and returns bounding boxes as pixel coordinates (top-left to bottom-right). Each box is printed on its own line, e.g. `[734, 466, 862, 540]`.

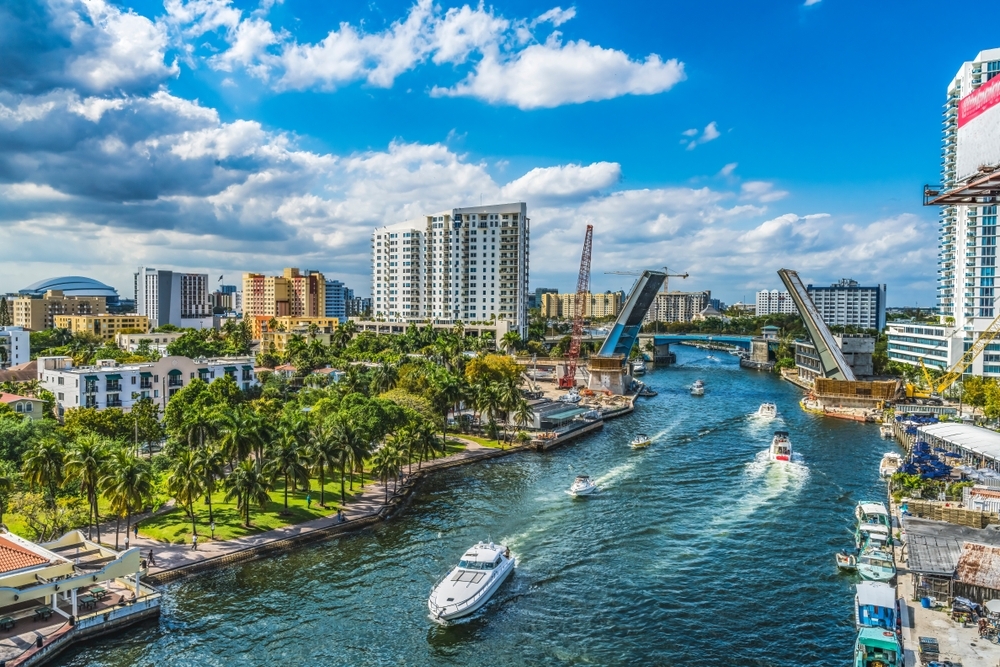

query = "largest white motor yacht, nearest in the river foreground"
[427, 542, 514, 621]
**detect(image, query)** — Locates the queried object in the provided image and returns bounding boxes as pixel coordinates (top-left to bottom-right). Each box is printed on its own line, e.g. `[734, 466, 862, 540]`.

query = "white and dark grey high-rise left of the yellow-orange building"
[134, 266, 212, 329]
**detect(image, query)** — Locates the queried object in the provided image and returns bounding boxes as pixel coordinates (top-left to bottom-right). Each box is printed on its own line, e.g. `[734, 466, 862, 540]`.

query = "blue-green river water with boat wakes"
[60, 346, 887, 667]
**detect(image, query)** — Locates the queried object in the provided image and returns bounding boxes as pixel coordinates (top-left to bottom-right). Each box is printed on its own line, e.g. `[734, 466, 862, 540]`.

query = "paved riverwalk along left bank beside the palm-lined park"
[101, 436, 521, 580]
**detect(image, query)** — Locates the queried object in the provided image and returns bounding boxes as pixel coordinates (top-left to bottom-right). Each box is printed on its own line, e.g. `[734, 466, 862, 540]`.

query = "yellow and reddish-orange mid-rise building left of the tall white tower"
[243, 268, 326, 318]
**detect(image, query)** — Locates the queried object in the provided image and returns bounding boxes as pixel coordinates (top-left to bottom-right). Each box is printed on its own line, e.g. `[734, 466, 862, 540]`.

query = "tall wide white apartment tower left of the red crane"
[372, 202, 530, 337]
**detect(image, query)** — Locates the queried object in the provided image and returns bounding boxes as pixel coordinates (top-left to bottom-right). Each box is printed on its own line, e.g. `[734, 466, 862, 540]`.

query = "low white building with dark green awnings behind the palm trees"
[38, 357, 257, 419]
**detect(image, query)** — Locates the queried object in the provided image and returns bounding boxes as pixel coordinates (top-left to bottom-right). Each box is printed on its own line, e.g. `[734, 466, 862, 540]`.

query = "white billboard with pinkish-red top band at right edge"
[955, 76, 1000, 181]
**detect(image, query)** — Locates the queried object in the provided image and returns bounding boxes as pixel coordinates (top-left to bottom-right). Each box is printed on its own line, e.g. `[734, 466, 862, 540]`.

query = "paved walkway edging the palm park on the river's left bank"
[101, 436, 504, 574]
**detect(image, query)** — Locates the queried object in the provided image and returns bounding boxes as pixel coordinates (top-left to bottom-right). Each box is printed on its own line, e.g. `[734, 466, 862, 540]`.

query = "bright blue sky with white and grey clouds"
[0, 0, 1000, 306]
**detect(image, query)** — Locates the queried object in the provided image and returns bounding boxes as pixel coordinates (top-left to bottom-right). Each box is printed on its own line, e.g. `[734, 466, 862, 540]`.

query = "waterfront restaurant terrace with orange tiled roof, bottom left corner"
[0, 530, 160, 665]
